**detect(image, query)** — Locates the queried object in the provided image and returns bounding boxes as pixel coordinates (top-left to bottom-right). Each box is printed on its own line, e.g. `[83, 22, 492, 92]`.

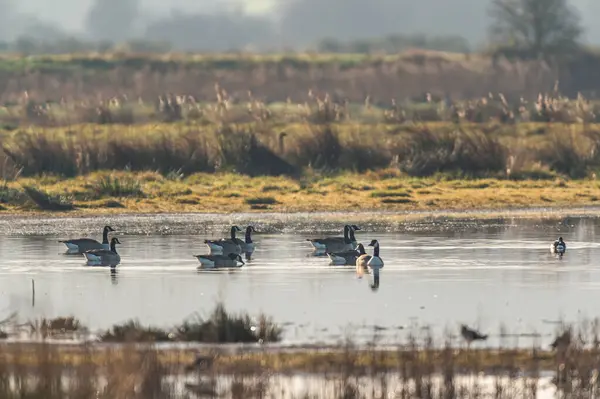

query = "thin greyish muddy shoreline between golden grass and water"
[0, 206, 600, 236]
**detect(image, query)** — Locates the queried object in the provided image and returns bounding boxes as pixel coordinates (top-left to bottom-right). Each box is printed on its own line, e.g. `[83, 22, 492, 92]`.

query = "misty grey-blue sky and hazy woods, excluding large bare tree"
[0, 0, 600, 52]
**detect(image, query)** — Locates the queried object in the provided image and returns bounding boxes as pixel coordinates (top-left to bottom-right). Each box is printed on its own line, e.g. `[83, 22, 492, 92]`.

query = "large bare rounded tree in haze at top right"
[490, 0, 583, 57]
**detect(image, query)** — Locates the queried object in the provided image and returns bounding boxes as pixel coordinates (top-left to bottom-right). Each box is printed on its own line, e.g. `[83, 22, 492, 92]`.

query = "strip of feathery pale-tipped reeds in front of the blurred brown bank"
[0, 85, 600, 130]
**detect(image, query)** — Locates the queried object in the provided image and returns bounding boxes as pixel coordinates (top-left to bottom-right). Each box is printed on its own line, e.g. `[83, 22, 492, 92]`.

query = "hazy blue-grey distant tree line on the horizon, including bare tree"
[0, 0, 583, 58]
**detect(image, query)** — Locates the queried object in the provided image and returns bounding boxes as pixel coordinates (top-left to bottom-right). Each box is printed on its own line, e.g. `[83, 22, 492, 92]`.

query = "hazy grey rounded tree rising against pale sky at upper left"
[85, 0, 140, 42]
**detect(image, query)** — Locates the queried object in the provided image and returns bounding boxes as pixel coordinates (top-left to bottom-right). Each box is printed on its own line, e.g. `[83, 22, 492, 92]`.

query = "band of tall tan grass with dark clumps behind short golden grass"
[0, 123, 600, 180]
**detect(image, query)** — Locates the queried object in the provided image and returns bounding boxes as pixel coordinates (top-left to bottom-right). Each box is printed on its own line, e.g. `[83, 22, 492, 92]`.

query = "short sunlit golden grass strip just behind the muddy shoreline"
[0, 170, 600, 214]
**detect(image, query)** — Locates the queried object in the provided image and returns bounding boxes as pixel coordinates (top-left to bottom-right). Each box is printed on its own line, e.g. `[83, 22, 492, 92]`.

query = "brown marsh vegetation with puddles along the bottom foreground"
[0, 312, 600, 398]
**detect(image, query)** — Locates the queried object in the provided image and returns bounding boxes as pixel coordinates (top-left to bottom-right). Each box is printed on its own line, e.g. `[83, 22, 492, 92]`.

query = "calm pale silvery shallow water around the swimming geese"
[0, 215, 600, 345]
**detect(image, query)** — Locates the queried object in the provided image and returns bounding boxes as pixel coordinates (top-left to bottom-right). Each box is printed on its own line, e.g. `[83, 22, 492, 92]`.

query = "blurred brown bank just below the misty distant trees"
[0, 51, 600, 104]
